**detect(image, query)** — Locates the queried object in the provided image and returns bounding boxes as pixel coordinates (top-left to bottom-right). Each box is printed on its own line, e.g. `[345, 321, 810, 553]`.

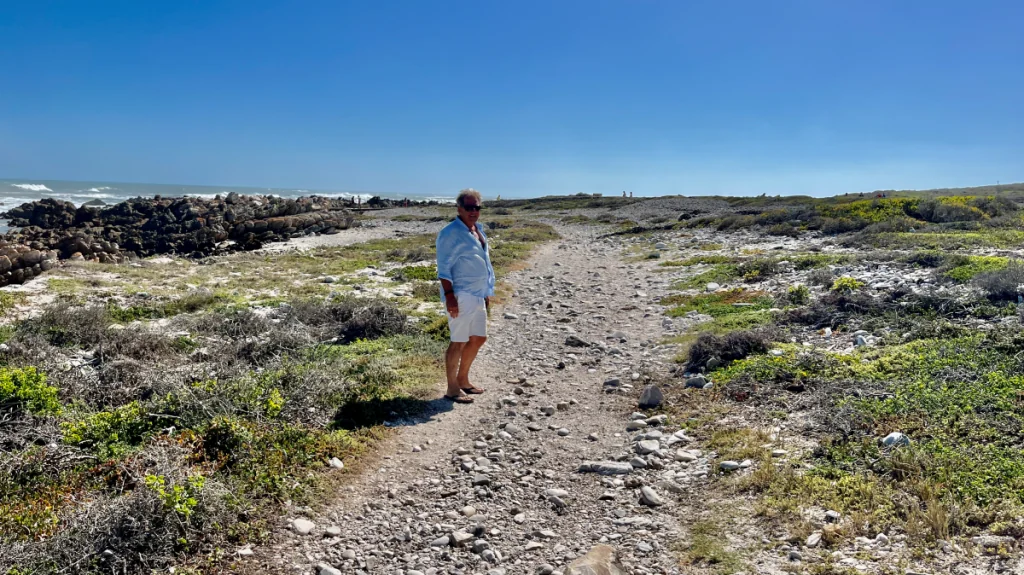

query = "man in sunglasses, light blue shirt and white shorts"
[437, 188, 495, 403]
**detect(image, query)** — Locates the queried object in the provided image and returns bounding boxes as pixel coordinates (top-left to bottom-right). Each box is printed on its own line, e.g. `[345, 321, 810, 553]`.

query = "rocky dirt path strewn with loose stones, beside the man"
[256, 230, 708, 575]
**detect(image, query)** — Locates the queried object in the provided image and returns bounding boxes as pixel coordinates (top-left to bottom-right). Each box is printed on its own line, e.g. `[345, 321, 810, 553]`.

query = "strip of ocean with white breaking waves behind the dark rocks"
[0, 179, 454, 212]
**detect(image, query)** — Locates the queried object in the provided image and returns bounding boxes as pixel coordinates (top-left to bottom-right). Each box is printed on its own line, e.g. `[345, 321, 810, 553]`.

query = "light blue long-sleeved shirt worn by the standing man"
[436, 218, 495, 301]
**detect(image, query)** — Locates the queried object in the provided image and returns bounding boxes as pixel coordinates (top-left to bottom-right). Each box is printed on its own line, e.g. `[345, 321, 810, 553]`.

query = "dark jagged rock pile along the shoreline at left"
[2, 192, 354, 262]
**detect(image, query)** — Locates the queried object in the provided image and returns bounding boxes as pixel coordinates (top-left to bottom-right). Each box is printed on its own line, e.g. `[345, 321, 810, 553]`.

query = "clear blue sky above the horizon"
[0, 0, 1024, 196]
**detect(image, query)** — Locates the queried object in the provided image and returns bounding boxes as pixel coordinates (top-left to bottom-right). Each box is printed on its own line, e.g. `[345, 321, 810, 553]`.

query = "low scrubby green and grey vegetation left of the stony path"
[0, 218, 557, 575]
